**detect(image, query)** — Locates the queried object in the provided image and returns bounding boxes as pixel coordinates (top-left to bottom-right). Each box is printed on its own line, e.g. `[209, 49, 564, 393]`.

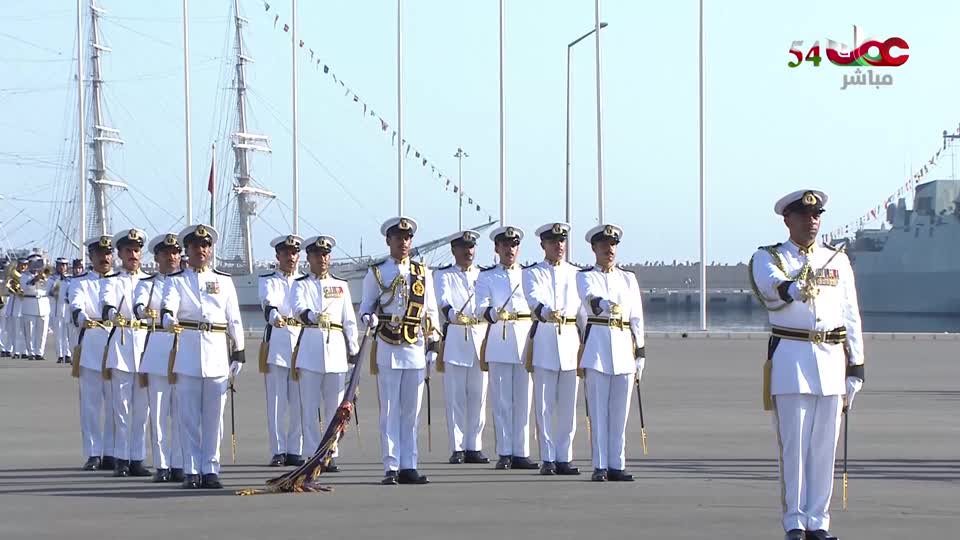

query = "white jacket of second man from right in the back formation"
[523, 261, 580, 371]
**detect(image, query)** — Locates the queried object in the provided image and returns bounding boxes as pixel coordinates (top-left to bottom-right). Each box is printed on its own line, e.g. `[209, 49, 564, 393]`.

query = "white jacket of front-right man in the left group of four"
[162, 268, 244, 378]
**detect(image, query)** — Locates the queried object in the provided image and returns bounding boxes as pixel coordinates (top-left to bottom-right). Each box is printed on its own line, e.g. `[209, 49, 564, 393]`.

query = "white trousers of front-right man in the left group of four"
[176, 374, 230, 474]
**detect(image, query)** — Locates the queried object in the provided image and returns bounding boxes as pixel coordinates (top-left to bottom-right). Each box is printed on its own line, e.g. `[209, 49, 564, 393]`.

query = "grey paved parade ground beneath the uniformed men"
[0, 335, 960, 540]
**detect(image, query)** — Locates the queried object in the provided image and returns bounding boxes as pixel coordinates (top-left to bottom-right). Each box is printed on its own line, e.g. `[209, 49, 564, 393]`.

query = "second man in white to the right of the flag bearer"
[476, 225, 540, 470]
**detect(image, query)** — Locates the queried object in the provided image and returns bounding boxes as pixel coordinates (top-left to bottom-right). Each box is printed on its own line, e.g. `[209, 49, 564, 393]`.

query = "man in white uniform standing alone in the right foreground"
[750, 189, 864, 540]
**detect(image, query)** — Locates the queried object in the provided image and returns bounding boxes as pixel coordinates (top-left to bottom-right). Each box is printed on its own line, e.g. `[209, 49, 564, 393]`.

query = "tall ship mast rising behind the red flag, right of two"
[217, 0, 276, 275]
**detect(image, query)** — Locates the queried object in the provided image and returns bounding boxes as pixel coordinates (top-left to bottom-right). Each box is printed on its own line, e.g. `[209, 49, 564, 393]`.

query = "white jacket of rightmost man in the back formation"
[577, 266, 644, 375]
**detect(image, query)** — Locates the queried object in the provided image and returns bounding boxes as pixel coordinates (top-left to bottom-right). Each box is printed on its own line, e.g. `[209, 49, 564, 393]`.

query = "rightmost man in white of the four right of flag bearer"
[577, 225, 646, 482]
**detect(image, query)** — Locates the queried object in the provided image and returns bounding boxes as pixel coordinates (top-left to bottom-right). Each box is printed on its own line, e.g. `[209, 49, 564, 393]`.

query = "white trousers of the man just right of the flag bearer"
[443, 362, 487, 452]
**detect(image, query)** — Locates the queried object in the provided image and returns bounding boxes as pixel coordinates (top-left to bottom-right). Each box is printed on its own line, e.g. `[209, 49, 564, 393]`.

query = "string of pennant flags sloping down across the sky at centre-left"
[263, 1, 493, 221]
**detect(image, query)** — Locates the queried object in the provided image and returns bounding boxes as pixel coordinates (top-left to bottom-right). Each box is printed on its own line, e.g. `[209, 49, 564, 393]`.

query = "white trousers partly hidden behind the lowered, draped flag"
[300, 369, 347, 457]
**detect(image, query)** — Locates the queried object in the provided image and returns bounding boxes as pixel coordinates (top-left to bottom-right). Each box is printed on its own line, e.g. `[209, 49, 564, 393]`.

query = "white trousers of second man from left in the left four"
[110, 369, 150, 461]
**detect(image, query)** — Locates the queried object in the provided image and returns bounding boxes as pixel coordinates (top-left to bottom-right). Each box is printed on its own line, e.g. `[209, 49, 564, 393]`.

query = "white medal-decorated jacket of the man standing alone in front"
[751, 240, 863, 396]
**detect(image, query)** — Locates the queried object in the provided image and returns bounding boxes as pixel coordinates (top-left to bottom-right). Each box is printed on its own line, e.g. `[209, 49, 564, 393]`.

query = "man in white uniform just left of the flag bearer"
[292, 234, 360, 473]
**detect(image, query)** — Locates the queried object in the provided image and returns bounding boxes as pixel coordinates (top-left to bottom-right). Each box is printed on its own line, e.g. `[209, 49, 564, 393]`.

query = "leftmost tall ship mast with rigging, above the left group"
[81, 0, 127, 234]
